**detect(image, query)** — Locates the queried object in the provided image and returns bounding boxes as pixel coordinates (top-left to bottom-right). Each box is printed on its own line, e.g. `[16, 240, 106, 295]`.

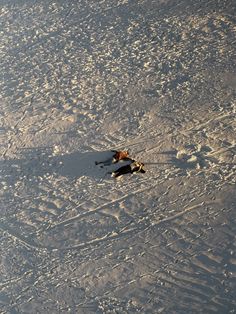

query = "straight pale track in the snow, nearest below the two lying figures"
[48, 182, 159, 230]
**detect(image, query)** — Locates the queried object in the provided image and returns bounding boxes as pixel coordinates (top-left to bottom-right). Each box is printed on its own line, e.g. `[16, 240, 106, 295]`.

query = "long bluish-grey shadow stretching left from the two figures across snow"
[0, 148, 120, 184]
